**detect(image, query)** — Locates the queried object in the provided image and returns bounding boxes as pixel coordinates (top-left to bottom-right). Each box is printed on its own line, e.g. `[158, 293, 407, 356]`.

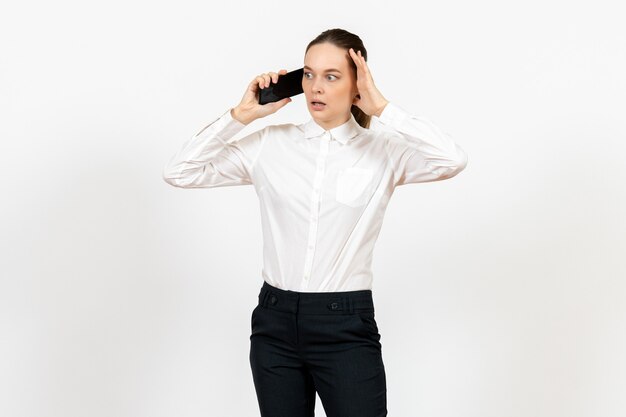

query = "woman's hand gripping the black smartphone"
[230, 69, 291, 125]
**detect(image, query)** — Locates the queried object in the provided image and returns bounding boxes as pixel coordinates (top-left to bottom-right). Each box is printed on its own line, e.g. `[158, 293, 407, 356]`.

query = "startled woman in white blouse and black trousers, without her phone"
[164, 29, 467, 417]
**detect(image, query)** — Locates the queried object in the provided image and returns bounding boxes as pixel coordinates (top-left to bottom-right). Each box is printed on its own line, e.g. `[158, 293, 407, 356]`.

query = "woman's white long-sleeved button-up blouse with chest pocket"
[163, 102, 467, 292]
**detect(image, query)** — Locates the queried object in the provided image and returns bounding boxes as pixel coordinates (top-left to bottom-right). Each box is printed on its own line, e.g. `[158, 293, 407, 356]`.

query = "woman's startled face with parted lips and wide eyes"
[302, 42, 358, 130]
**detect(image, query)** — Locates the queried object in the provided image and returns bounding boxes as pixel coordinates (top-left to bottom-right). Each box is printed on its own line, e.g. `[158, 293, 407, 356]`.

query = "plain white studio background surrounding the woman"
[0, 0, 626, 417]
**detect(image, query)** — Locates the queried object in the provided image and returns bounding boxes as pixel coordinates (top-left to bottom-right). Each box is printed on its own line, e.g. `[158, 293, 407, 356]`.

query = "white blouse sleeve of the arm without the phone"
[374, 102, 467, 186]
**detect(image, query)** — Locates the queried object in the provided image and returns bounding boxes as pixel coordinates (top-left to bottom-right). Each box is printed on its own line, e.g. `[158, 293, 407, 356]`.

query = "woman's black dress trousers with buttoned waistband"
[250, 281, 387, 417]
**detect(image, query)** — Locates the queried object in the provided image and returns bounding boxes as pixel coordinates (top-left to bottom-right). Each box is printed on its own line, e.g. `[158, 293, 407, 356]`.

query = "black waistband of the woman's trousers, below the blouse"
[259, 280, 374, 314]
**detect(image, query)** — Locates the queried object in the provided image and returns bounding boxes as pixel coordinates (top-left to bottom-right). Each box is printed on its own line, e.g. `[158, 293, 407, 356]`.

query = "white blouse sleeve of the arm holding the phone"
[163, 109, 267, 188]
